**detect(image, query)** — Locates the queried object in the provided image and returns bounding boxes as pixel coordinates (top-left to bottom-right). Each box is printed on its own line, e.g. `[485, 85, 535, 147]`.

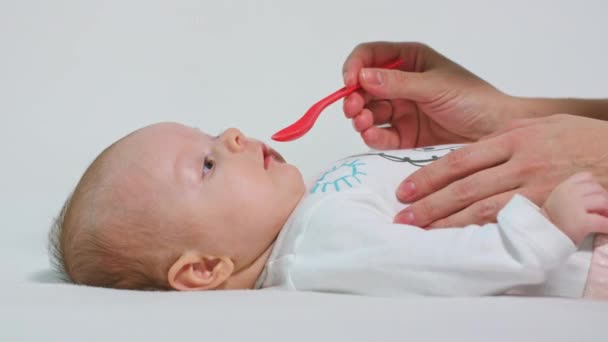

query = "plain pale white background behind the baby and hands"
[0, 0, 608, 286]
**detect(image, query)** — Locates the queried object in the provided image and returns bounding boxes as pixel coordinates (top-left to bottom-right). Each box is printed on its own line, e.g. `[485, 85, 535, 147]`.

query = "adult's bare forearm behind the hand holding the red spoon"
[511, 97, 608, 120]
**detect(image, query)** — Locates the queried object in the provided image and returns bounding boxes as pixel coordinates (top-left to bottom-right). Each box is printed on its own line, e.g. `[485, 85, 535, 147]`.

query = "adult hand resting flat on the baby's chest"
[395, 114, 608, 228]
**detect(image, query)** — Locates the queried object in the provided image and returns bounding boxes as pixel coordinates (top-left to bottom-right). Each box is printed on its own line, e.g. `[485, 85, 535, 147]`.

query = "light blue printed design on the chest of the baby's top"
[310, 159, 367, 194]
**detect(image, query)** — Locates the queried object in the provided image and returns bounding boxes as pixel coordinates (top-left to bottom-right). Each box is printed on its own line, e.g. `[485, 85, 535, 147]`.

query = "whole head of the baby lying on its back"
[50, 123, 304, 290]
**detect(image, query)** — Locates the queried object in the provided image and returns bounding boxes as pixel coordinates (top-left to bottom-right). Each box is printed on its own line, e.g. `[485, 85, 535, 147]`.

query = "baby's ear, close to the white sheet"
[167, 252, 234, 291]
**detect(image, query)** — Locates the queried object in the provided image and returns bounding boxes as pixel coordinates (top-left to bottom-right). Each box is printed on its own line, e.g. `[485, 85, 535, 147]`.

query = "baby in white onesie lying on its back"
[50, 123, 608, 297]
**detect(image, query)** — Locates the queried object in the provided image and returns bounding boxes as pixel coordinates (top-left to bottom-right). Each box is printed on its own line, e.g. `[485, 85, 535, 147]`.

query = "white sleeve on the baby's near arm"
[292, 195, 576, 296]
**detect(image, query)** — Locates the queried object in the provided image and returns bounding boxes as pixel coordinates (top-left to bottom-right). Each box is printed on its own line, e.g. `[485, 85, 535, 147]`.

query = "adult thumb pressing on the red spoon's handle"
[359, 68, 439, 101]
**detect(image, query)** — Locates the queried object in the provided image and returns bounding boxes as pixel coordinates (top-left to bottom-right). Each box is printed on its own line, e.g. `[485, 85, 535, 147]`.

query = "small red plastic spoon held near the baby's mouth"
[272, 59, 403, 141]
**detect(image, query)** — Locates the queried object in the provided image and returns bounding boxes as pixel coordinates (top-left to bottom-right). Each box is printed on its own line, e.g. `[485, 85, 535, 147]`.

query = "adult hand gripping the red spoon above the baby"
[343, 42, 515, 149]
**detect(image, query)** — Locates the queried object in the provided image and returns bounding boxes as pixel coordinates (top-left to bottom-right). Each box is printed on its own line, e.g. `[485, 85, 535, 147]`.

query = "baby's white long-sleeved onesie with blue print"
[256, 145, 591, 297]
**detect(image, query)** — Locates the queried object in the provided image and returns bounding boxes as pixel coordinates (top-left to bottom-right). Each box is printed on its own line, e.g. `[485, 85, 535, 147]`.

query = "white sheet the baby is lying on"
[0, 283, 608, 342]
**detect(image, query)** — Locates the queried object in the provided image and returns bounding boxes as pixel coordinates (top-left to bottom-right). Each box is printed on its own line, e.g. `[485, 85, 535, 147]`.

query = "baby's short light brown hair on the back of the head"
[48, 143, 177, 290]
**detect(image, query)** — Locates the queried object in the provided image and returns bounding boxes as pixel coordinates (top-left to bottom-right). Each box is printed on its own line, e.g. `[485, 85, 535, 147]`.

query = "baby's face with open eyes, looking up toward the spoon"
[121, 123, 304, 263]
